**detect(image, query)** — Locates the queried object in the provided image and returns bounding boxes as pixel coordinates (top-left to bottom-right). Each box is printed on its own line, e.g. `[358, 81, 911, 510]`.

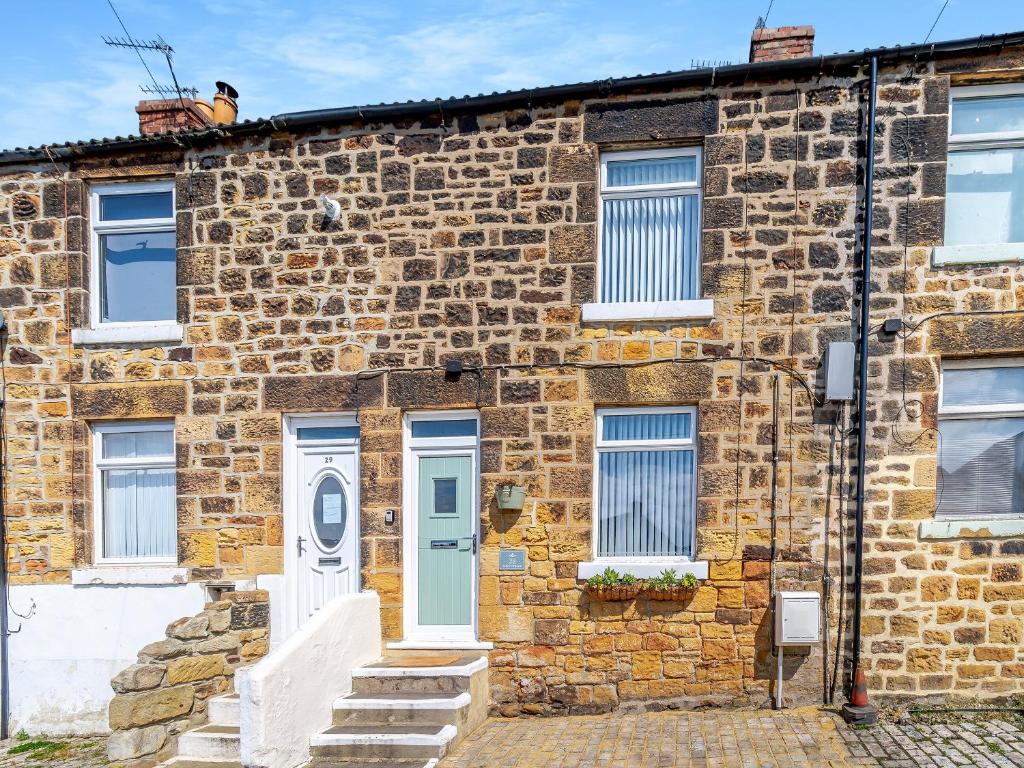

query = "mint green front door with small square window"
[417, 456, 476, 628]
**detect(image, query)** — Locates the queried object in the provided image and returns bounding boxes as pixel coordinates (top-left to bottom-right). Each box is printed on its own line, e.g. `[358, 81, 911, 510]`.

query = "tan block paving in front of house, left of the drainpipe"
[439, 708, 878, 768]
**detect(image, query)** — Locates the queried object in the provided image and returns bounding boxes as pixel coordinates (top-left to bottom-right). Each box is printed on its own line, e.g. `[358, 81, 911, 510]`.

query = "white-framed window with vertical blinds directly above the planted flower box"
[594, 408, 696, 558]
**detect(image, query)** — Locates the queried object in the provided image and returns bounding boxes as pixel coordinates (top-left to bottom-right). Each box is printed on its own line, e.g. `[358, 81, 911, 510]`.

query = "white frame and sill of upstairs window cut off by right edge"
[932, 83, 1024, 266]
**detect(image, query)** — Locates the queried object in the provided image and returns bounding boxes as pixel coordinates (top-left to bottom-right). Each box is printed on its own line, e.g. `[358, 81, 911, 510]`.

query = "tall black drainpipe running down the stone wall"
[850, 56, 879, 696]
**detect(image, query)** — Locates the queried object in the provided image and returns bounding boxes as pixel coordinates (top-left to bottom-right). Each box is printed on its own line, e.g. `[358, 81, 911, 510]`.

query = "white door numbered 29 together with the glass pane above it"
[285, 417, 359, 629]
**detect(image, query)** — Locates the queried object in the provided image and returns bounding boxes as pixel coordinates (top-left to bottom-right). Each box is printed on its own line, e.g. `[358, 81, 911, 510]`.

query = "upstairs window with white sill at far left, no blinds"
[74, 180, 182, 343]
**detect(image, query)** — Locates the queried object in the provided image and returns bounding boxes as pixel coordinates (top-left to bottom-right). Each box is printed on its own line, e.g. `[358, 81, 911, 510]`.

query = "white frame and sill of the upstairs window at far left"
[72, 179, 184, 344]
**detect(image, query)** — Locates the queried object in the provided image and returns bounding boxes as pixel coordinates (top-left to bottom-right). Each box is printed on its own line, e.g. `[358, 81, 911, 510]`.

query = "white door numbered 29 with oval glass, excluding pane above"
[294, 430, 359, 624]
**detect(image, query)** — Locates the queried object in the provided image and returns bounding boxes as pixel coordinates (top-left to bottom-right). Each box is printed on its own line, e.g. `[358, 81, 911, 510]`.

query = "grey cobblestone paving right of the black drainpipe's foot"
[840, 720, 1024, 768]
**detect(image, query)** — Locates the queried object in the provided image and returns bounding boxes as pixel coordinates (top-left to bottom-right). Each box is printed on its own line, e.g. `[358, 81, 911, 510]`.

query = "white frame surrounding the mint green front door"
[399, 411, 480, 648]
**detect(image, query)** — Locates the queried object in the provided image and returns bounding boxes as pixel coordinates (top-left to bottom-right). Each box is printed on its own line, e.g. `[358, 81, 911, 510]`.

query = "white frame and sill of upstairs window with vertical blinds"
[582, 146, 715, 322]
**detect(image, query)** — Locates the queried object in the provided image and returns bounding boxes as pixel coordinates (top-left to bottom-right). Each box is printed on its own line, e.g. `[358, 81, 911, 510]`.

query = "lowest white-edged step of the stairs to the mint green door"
[309, 725, 458, 763]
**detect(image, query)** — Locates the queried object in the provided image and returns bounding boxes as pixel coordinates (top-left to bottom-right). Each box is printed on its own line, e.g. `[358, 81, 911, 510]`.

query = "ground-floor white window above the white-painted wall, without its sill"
[92, 422, 177, 564]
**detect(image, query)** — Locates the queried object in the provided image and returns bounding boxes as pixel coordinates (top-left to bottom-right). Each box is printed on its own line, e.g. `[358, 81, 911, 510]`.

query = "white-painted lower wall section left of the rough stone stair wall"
[9, 584, 206, 735]
